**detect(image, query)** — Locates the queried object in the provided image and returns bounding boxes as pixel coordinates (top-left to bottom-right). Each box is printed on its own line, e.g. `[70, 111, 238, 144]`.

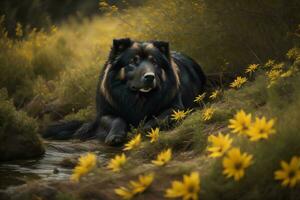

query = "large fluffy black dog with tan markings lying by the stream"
[44, 38, 206, 145]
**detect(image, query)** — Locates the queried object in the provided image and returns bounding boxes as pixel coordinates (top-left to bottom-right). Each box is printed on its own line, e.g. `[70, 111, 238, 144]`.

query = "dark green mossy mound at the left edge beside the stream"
[0, 89, 44, 161]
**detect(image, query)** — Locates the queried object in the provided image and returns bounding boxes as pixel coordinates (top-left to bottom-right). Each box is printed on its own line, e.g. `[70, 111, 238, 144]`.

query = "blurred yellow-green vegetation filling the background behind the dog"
[0, 0, 300, 133]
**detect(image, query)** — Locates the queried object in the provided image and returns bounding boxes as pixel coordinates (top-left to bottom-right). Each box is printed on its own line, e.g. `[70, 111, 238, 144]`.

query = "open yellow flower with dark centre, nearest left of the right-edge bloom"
[223, 148, 253, 181]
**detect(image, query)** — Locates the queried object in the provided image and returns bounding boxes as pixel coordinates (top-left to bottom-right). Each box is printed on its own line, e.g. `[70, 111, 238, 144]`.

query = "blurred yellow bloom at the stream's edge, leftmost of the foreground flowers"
[71, 153, 97, 182]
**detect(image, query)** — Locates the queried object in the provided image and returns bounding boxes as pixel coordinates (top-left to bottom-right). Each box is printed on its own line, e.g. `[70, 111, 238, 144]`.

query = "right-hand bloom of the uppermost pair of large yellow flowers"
[247, 117, 275, 141]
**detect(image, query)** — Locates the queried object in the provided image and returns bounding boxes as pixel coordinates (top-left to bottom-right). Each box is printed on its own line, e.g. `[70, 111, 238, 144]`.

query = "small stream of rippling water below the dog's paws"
[0, 140, 119, 191]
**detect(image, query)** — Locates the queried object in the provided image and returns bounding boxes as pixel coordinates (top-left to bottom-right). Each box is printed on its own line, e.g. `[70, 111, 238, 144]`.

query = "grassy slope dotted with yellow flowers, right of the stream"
[55, 53, 300, 199]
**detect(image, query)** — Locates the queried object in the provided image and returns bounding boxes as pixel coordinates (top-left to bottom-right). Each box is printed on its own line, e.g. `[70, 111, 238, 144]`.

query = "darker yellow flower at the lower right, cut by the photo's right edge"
[274, 156, 300, 187]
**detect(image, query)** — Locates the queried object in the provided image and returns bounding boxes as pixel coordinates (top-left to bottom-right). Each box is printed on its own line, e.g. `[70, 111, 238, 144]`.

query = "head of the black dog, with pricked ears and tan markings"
[109, 38, 178, 93]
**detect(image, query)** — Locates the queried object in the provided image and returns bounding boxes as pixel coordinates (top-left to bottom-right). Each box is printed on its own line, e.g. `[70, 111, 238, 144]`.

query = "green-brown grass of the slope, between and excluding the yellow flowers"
[6, 54, 300, 200]
